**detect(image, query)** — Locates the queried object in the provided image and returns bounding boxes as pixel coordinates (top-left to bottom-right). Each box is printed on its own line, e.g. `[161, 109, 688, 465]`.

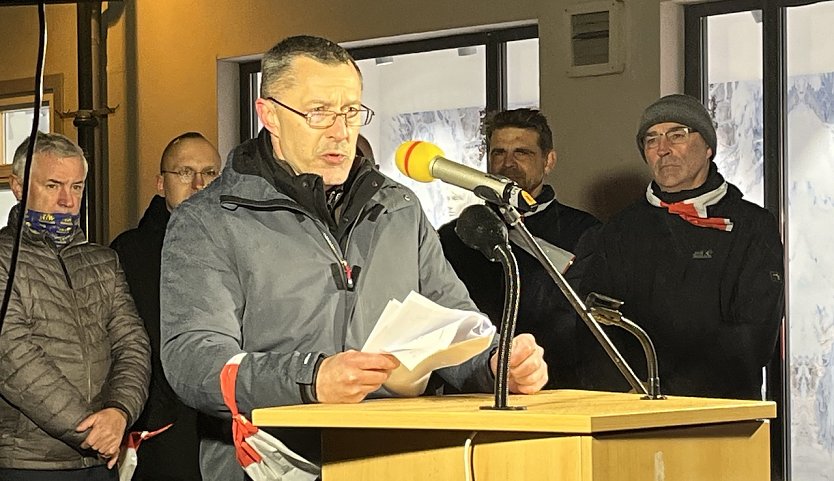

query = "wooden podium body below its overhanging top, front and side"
[322, 421, 770, 481]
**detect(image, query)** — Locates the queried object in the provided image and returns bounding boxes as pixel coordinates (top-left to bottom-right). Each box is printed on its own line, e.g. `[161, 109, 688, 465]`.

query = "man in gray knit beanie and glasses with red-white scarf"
[574, 95, 784, 399]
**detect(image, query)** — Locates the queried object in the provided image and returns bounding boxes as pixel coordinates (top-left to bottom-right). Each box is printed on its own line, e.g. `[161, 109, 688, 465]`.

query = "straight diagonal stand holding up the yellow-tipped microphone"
[488, 197, 663, 399]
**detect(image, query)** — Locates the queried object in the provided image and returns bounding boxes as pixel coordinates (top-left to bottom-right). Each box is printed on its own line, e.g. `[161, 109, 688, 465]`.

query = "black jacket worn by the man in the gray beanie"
[575, 175, 784, 399]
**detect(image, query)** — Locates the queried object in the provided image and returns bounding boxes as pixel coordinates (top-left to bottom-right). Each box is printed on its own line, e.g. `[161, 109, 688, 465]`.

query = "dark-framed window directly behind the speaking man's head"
[240, 26, 539, 227]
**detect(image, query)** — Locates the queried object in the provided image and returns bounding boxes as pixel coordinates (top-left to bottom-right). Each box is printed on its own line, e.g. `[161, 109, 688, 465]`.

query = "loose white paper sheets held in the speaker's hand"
[362, 291, 495, 396]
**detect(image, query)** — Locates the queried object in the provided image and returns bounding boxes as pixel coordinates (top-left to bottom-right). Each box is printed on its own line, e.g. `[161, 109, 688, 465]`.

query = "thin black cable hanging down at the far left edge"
[0, 0, 46, 333]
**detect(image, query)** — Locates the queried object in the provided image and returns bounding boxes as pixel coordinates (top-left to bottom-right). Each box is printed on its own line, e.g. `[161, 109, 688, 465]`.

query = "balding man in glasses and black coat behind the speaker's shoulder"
[111, 132, 220, 481]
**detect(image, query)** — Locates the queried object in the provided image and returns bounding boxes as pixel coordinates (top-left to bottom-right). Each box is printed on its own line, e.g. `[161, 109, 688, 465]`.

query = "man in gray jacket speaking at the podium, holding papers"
[160, 36, 547, 481]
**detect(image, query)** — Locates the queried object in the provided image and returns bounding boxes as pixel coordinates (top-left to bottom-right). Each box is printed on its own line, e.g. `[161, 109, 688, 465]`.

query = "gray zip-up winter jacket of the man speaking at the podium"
[161, 132, 493, 481]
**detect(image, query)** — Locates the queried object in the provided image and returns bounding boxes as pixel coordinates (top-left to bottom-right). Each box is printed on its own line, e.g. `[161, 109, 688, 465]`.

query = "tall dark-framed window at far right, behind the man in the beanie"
[685, 0, 834, 481]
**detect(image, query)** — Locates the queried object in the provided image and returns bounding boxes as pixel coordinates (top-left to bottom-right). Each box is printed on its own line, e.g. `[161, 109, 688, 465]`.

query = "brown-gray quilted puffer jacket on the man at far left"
[0, 205, 150, 470]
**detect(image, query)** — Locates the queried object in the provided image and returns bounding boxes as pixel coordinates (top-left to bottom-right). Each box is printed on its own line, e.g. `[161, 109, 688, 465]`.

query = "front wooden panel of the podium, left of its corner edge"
[322, 429, 580, 481]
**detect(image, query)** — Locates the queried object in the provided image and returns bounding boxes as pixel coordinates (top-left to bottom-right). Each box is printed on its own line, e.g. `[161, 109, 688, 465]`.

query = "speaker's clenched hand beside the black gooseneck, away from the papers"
[489, 334, 547, 394]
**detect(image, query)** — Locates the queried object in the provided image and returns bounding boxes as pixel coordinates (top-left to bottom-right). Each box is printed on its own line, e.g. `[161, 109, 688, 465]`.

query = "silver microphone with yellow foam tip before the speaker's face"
[396, 140, 537, 212]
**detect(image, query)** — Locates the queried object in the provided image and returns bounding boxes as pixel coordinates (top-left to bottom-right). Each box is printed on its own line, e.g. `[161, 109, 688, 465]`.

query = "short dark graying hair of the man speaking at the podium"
[261, 35, 362, 98]
